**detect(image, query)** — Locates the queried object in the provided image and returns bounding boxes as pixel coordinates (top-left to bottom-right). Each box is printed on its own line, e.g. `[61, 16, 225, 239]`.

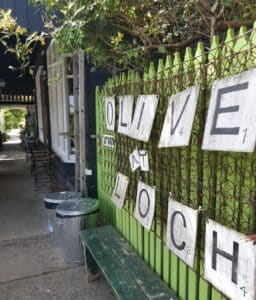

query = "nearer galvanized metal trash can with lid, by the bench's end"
[56, 198, 99, 265]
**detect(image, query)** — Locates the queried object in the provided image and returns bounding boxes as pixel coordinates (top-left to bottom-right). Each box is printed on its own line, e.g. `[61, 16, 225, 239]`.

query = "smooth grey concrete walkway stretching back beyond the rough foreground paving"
[0, 144, 47, 241]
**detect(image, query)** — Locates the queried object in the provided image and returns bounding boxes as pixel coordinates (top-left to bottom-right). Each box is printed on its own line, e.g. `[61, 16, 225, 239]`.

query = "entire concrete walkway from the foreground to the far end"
[0, 143, 114, 300]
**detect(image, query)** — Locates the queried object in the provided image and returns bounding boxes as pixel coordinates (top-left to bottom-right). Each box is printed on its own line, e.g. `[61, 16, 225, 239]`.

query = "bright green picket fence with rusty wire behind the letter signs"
[96, 23, 256, 300]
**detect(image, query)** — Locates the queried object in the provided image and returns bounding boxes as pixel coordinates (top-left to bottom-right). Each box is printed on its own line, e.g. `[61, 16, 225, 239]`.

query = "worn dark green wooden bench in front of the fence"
[80, 225, 178, 300]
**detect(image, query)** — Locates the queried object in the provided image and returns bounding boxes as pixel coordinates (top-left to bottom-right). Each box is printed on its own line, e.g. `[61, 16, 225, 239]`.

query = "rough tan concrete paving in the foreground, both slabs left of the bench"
[0, 235, 114, 300]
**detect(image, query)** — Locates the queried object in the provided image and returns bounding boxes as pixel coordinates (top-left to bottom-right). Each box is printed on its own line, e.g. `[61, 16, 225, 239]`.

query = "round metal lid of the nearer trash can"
[56, 198, 99, 217]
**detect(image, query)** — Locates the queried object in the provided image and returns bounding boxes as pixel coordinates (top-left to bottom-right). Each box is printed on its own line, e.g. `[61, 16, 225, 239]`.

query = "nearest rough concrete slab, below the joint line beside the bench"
[0, 266, 115, 300]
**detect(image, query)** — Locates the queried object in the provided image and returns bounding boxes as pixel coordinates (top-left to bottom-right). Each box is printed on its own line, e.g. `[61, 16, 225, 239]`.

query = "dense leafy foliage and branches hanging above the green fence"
[32, 0, 256, 69]
